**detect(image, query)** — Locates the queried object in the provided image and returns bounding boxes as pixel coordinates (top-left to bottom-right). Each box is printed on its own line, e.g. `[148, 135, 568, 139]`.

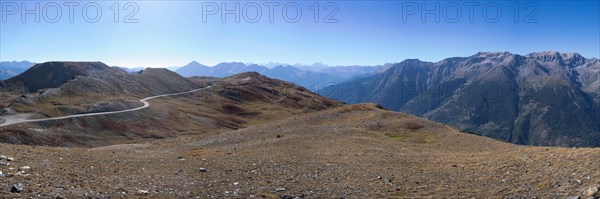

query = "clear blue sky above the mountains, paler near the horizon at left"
[0, 0, 600, 67]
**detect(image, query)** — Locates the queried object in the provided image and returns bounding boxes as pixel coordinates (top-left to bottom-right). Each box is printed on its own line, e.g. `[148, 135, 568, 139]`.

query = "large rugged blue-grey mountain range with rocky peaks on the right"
[323, 52, 600, 147]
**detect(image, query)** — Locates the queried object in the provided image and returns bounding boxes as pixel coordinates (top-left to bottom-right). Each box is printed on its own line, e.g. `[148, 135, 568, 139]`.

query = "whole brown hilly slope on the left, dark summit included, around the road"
[0, 62, 341, 146]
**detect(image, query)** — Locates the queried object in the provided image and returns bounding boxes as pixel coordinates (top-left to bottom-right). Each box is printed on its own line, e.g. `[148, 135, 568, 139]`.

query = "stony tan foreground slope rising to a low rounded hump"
[0, 105, 600, 198]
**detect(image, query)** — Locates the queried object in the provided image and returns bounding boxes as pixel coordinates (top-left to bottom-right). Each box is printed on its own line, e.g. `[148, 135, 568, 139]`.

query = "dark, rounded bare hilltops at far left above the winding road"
[0, 62, 199, 95]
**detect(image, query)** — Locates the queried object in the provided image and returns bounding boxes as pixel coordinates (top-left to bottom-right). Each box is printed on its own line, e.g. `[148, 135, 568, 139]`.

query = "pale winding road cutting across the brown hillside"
[0, 86, 213, 127]
